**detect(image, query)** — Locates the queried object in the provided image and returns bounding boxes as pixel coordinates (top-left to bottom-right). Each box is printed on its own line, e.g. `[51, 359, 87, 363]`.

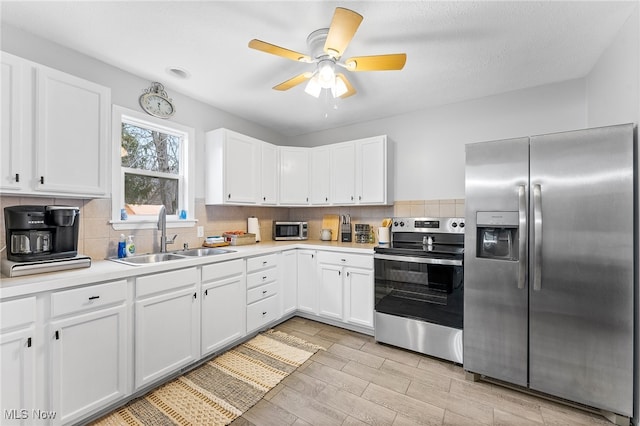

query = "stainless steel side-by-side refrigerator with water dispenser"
[464, 124, 636, 417]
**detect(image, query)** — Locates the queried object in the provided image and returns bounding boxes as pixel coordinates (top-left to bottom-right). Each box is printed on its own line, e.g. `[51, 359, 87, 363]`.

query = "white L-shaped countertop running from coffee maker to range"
[0, 240, 376, 300]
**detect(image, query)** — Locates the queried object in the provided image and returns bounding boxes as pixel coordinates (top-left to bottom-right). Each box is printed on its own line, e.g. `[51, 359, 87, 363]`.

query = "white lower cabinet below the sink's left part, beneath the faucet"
[135, 268, 200, 389]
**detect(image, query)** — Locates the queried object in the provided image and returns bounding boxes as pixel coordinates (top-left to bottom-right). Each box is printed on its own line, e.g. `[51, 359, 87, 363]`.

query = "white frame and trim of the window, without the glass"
[110, 105, 197, 230]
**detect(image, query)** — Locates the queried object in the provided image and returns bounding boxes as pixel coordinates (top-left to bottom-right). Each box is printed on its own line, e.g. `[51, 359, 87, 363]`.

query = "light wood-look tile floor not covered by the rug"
[232, 317, 611, 426]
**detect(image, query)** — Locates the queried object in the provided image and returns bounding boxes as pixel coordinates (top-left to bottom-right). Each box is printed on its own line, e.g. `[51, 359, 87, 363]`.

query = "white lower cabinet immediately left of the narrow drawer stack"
[201, 259, 246, 356]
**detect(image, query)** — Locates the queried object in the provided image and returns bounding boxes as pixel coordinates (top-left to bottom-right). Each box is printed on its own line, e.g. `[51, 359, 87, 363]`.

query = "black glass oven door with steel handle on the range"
[374, 253, 464, 330]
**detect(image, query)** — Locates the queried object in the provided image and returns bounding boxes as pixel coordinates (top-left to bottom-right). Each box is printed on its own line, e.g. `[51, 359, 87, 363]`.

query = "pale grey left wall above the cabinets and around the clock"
[0, 25, 284, 198]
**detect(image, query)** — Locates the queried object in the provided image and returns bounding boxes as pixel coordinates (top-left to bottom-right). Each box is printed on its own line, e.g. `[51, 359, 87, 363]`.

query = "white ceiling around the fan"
[0, 0, 637, 136]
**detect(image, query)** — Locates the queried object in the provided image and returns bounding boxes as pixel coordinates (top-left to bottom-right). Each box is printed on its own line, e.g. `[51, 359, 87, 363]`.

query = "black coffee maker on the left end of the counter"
[4, 206, 80, 262]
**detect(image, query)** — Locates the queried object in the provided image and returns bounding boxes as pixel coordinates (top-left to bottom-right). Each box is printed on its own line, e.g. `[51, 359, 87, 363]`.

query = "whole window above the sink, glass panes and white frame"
[112, 106, 194, 229]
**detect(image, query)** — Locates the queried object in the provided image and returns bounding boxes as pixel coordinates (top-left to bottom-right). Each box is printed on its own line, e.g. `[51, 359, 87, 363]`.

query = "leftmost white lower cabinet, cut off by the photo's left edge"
[0, 297, 36, 425]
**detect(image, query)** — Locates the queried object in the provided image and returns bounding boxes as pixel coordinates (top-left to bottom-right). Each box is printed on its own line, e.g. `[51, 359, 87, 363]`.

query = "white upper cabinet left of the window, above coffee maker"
[1, 52, 111, 197]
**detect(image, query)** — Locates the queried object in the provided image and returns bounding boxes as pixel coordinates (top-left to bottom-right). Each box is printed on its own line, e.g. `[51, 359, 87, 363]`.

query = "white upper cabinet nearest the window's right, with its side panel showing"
[204, 129, 263, 204]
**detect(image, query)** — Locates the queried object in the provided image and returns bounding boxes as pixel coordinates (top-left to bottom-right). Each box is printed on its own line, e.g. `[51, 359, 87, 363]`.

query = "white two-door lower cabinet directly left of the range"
[318, 251, 374, 329]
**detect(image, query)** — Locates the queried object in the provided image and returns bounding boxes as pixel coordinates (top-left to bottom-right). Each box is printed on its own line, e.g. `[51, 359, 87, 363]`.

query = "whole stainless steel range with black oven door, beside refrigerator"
[374, 217, 464, 364]
